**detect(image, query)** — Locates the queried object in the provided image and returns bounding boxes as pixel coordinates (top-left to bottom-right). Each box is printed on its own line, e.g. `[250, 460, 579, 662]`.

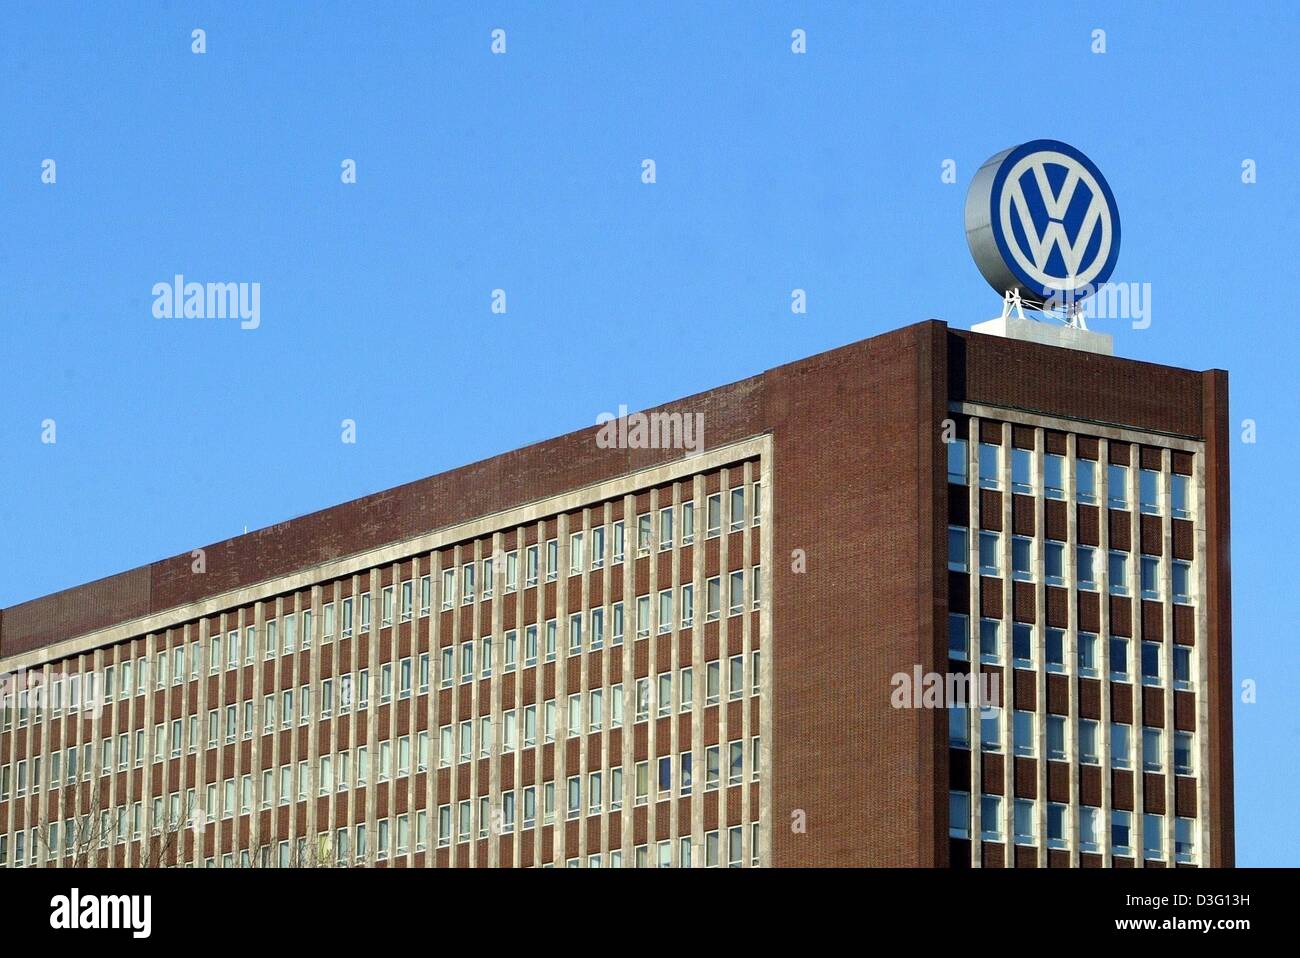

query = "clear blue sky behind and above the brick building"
[0, 3, 1300, 864]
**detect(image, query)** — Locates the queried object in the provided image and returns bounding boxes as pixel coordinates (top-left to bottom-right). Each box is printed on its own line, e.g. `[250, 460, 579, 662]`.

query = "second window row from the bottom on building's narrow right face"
[948, 706, 1196, 775]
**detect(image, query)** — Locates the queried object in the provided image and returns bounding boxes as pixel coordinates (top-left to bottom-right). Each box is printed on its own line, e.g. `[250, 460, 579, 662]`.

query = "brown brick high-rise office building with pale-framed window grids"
[0, 321, 1232, 867]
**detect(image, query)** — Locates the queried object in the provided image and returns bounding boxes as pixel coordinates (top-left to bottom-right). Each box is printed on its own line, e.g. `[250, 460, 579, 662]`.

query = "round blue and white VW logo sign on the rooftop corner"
[966, 139, 1119, 303]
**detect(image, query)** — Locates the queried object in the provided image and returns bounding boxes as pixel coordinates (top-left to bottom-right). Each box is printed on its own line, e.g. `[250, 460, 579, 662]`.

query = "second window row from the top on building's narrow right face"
[948, 525, 1192, 604]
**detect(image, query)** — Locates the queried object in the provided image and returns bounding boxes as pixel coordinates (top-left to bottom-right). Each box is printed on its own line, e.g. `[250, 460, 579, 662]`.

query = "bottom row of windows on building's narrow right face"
[948, 792, 1196, 863]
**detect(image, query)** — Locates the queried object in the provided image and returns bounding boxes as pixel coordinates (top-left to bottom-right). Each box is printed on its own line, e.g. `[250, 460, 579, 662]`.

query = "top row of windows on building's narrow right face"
[948, 439, 1191, 519]
